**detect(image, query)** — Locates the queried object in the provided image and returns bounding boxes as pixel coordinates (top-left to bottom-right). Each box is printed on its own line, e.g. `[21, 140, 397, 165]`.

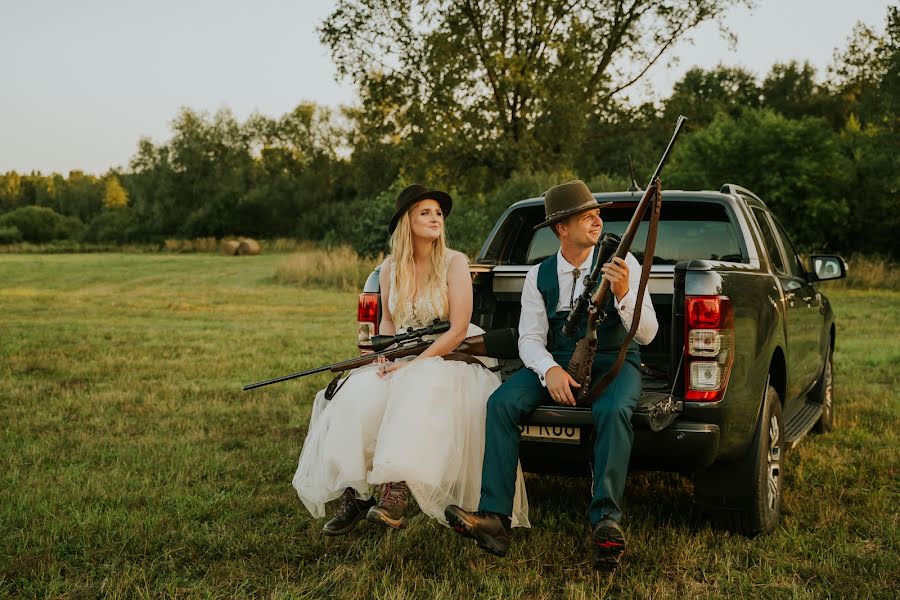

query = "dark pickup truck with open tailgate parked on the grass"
[358, 184, 846, 536]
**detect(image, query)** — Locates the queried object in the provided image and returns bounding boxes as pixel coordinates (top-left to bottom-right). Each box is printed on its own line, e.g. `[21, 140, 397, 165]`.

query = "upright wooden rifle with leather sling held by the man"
[563, 116, 687, 404]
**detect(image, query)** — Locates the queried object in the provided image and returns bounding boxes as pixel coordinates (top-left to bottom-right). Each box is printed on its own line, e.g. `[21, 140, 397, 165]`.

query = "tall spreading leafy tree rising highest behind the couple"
[320, 0, 748, 189]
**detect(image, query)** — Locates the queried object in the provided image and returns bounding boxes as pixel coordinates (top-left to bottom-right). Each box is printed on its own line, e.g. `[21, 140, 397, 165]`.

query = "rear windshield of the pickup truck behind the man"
[507, 201, 745, 265]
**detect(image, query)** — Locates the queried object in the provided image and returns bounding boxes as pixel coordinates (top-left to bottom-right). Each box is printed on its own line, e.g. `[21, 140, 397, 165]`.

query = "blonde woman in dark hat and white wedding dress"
[293, 184, 530, 535]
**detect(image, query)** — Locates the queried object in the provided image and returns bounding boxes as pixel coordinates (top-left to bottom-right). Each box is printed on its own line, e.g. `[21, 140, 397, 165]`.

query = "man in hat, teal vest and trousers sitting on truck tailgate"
[444, 180, 658, 570]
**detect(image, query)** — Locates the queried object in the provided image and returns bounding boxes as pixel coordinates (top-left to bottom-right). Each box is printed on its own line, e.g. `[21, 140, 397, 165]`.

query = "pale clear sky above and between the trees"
[0, 0, 896, 174]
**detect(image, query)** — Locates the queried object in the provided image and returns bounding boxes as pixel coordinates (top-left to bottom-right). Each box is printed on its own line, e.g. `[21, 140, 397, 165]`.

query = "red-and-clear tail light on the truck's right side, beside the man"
[684, 296, 734, 402]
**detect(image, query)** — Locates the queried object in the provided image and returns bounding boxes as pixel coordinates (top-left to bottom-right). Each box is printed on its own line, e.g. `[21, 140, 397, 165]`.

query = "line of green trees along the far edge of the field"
[0, 0, 900, 259]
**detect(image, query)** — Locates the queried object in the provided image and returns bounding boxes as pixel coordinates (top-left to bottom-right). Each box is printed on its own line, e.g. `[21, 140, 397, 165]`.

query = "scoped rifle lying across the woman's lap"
[242, 319, 518, 399]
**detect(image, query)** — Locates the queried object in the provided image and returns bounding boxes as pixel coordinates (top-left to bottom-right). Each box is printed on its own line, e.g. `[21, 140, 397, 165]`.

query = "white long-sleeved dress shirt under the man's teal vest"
[519, 251, 659, 386]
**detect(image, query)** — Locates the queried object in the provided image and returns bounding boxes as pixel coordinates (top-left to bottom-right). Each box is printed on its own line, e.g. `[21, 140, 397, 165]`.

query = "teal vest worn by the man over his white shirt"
[537, 247, 640, 368]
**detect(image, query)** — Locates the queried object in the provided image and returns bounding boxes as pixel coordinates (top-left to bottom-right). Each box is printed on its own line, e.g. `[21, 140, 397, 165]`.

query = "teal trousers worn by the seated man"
[478, 352, 641, 526]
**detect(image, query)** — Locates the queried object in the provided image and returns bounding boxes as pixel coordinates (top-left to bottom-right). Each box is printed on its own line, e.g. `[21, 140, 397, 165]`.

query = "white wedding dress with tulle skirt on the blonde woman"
[293, 251, 530, 527]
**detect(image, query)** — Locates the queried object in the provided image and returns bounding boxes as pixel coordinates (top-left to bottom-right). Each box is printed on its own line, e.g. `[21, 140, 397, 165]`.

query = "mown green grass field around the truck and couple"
[0, 254, 900, 599]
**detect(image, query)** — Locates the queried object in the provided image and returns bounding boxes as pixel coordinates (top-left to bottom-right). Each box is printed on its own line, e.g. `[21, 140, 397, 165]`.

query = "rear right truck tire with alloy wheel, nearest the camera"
[694, 385, 784, 537]
